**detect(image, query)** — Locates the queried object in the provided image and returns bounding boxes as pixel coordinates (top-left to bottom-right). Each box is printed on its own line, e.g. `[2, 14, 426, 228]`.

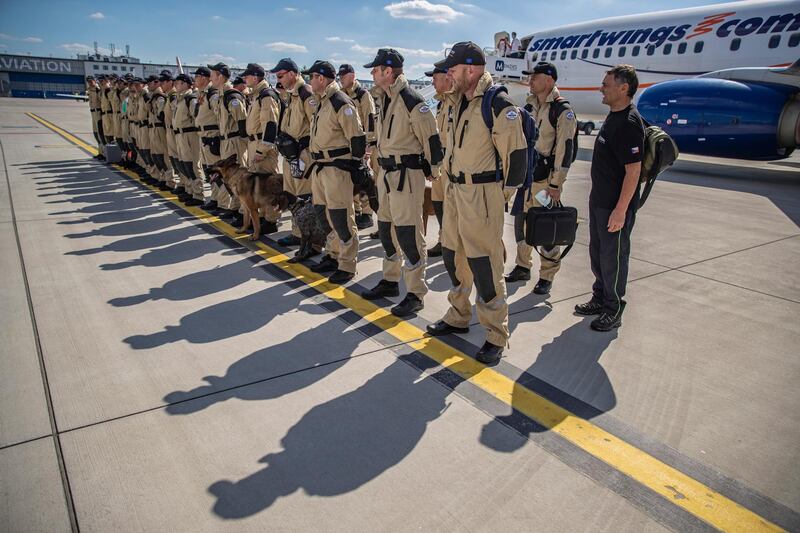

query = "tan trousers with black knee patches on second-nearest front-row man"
[378, 169, 428, 300]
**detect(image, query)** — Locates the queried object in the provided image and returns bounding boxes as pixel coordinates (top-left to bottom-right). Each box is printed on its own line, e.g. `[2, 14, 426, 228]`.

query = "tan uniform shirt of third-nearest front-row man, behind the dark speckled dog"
[309, 81, 367, 162]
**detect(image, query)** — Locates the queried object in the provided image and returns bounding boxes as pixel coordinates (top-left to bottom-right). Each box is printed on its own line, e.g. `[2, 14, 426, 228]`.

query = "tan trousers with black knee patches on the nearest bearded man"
[442, 182, 509, 346]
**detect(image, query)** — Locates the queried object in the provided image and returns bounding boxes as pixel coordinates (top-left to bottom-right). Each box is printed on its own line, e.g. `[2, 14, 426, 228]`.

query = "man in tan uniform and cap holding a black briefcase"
[506, 62, 578, 294]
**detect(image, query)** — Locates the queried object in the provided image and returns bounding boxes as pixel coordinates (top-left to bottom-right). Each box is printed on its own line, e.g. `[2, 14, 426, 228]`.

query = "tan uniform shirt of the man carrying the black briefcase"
[527, 87, 578, 187]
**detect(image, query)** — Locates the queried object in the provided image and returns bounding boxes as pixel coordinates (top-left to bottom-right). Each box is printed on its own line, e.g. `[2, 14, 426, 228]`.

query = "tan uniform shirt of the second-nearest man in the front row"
[378, 74, 443, 176]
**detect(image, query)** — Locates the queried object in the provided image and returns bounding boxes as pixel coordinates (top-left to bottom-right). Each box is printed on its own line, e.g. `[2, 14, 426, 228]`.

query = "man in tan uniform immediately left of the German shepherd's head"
[194, 67, 222, 212]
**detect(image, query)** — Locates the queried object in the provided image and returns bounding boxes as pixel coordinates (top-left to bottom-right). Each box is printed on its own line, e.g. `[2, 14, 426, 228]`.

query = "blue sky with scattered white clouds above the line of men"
[0, 0, 713, 79]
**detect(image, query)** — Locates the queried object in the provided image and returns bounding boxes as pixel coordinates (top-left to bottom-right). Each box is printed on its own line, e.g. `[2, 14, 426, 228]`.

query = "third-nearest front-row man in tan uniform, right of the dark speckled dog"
[303, 61, 367, 283]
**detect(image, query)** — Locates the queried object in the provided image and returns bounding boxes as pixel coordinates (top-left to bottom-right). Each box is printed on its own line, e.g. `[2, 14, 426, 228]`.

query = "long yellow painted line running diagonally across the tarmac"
[28, 113, 783, 532]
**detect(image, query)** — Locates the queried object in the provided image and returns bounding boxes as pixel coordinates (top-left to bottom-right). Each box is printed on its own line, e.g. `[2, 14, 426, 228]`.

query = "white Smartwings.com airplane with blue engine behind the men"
[485, 0, 800, 161]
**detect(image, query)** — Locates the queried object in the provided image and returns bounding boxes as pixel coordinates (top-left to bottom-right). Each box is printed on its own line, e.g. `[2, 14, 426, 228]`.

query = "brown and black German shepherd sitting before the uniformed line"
[208, 154, 288, 241]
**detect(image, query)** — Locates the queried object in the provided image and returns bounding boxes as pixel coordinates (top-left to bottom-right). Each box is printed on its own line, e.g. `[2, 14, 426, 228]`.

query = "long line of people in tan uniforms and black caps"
[87, 42, 575, 363]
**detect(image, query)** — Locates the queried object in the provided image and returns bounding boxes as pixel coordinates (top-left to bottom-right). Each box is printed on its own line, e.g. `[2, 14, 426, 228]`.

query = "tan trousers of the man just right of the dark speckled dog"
[311, 167, 358, 274]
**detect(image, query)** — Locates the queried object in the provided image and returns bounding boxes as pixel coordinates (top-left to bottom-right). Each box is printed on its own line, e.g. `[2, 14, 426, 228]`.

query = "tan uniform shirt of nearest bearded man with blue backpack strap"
[444, 72, 528, 187]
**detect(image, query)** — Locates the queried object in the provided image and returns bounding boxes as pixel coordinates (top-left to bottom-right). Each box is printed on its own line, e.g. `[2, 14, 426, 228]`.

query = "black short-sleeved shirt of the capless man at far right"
[589, 105, 644, 209]
